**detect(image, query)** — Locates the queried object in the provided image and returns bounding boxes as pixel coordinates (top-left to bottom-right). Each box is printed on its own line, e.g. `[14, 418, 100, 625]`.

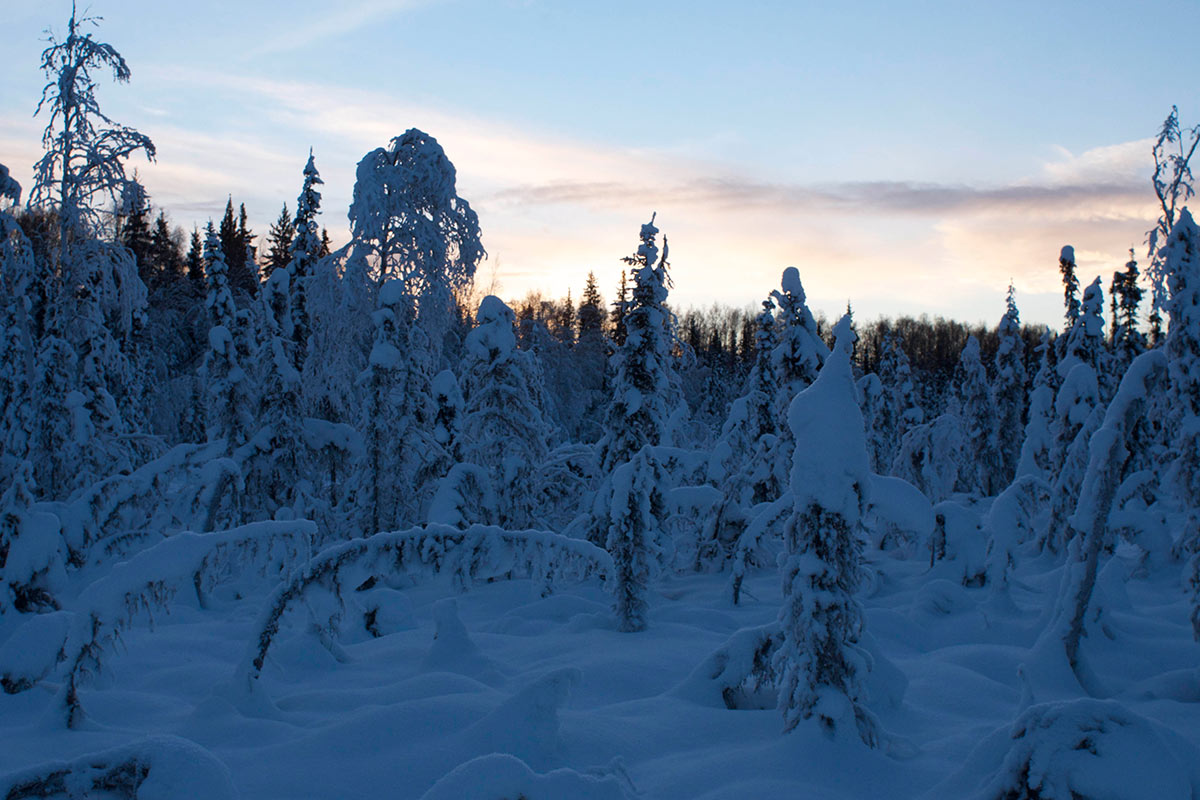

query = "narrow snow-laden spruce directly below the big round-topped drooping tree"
[352, 278, 413, 536]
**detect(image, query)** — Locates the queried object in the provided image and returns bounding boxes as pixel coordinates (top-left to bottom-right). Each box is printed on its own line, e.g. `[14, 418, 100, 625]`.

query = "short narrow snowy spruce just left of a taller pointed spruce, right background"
[954, 336, 1000, 497]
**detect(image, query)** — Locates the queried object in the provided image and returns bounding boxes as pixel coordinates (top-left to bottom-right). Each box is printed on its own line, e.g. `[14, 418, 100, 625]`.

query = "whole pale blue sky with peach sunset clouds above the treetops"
[0, 0, 1200, 326]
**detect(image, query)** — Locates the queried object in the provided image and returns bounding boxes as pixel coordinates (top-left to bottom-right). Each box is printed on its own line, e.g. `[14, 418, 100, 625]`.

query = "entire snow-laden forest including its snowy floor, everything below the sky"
[0, 6, 1200, 800]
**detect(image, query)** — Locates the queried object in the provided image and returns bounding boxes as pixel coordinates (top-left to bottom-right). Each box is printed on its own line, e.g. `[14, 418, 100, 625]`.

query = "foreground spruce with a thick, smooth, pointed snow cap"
[775, 315, 878, 747]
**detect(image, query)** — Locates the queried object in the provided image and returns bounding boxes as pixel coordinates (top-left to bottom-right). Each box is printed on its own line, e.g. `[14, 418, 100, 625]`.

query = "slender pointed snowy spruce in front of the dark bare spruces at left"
[202, 222, 253, 455]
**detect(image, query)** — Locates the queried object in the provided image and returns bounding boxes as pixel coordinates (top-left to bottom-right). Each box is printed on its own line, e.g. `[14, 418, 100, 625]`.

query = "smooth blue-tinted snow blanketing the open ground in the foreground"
[0, 542, 1200, 800]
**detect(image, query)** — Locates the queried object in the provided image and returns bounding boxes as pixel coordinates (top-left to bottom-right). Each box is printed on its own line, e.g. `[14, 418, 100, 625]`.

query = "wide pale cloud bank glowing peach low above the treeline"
[0, 67, 1154, 324]
